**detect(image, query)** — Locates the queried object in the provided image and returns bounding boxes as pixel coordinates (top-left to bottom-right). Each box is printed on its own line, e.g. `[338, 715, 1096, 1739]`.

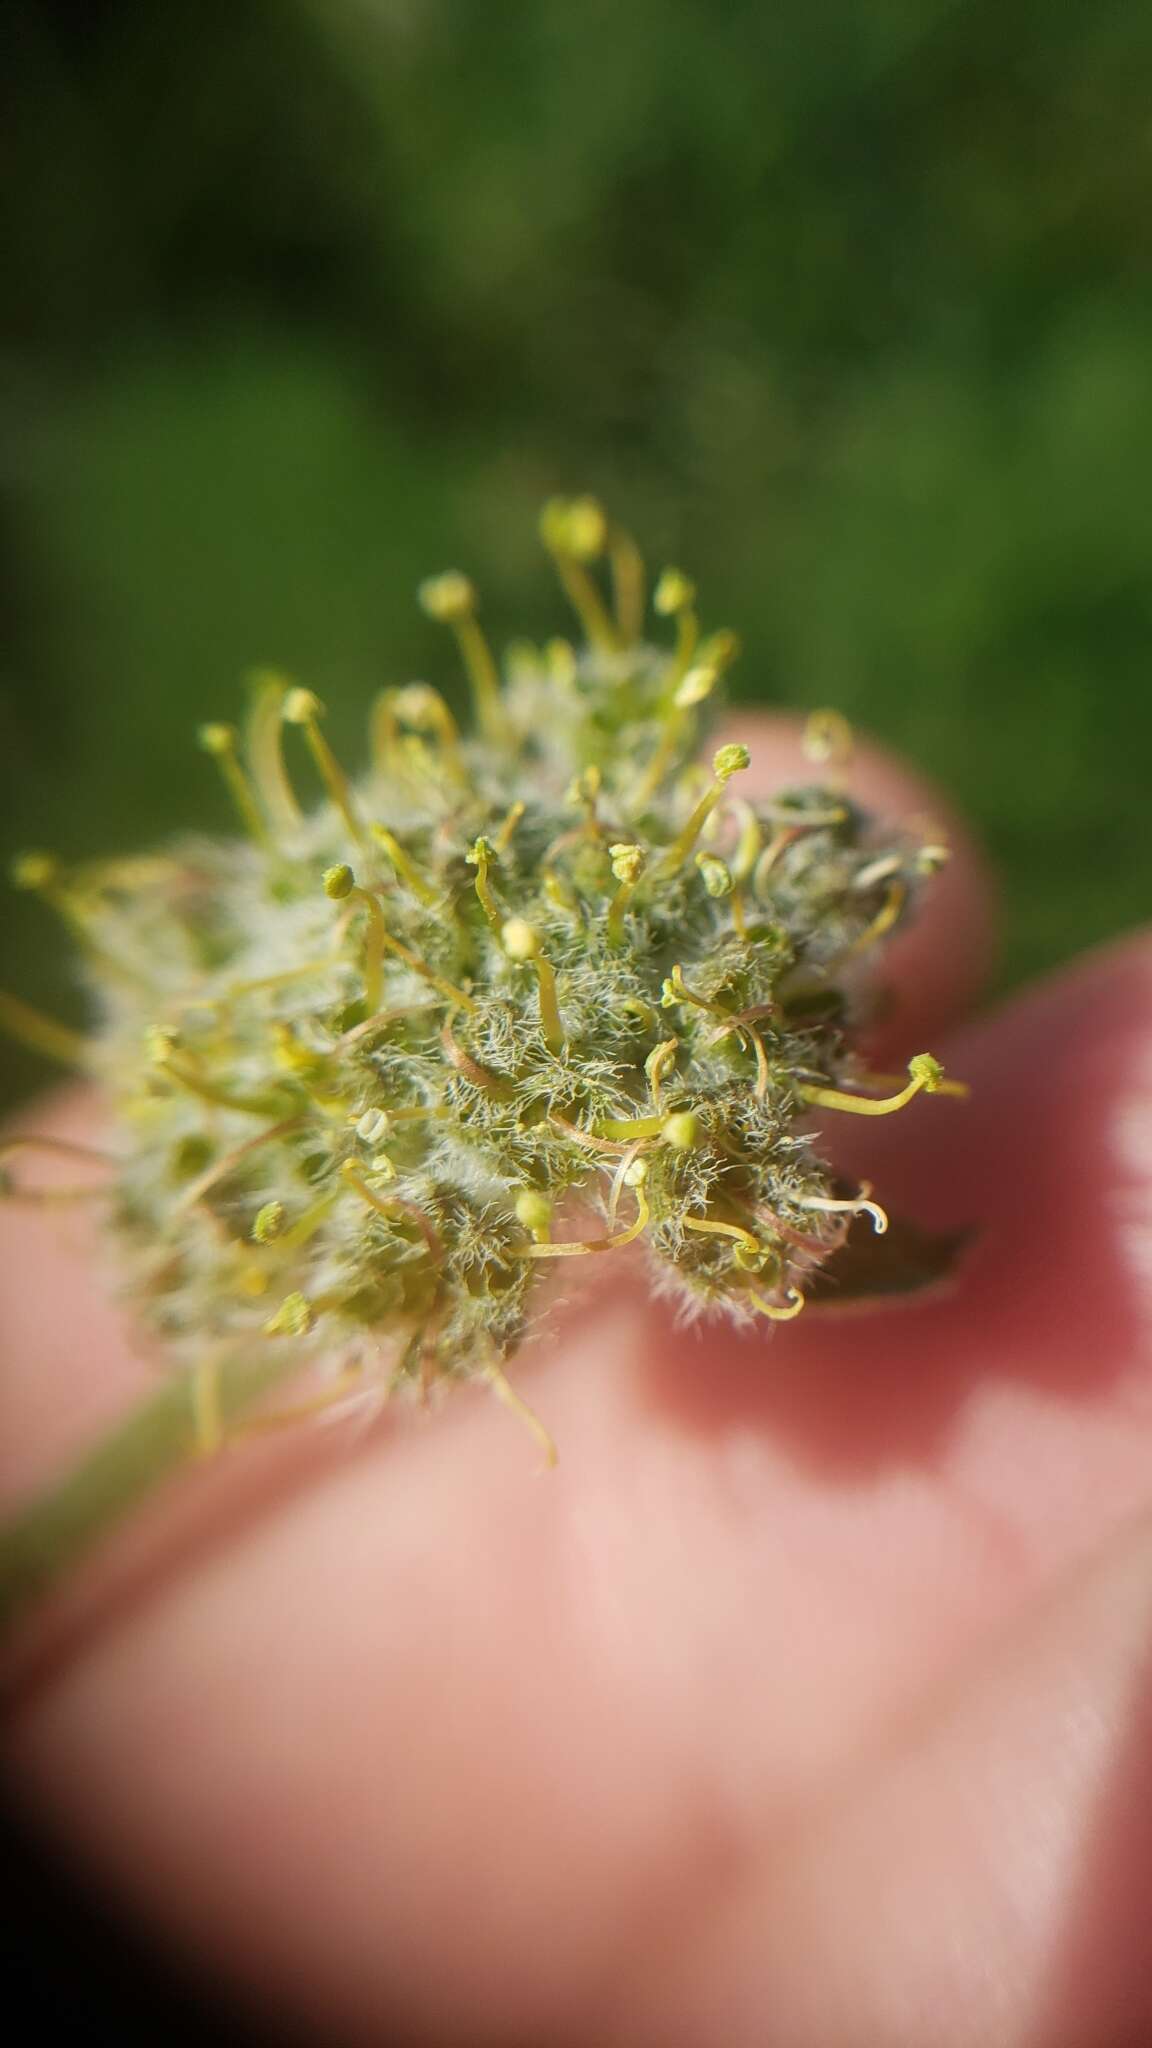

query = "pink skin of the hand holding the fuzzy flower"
[0, 721, 1152, 2048]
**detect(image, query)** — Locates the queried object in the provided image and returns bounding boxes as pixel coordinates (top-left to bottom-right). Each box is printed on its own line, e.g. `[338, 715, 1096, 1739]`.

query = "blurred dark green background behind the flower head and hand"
[0, 0, 1152, 1096]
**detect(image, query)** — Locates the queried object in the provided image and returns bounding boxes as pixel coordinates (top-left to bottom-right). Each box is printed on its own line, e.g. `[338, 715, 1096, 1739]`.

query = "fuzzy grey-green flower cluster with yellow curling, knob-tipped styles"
[8, 500, 951, 1442]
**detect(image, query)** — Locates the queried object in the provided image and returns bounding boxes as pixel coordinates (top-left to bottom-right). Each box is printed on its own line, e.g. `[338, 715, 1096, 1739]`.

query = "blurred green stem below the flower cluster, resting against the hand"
[0, 1343, 299, 1636]
